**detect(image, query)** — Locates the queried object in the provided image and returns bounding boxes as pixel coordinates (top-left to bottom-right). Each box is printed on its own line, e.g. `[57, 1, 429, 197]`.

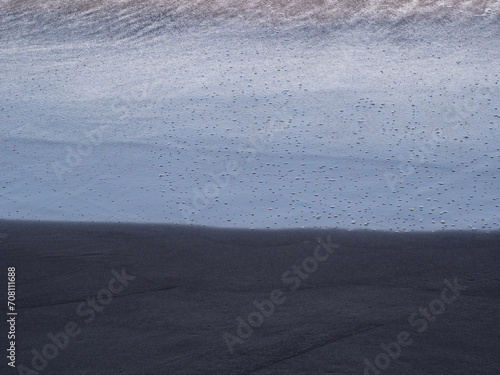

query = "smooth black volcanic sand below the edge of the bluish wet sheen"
[0, 221, 500, 375]
